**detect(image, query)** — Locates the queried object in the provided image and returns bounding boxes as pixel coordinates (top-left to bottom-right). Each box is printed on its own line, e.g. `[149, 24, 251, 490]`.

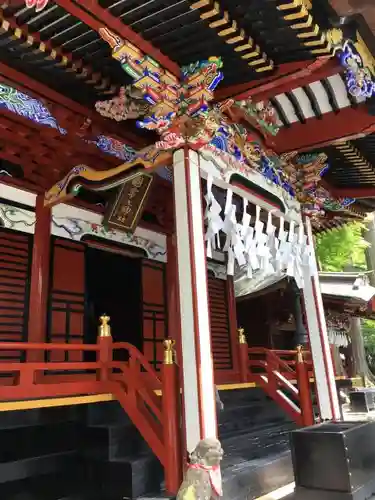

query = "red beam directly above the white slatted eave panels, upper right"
[215, 58, 343, 101]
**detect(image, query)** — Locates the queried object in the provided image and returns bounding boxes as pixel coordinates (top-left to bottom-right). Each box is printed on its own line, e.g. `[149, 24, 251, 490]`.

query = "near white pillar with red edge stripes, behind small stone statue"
[173, 149, 217, 452]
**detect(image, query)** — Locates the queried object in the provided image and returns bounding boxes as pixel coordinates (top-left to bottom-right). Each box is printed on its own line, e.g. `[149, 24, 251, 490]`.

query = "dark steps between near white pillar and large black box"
[219, 388, 296, 500]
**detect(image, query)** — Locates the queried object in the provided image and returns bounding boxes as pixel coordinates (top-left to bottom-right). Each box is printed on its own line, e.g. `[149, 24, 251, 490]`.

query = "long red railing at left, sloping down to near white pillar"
[0, 336, 181, 493]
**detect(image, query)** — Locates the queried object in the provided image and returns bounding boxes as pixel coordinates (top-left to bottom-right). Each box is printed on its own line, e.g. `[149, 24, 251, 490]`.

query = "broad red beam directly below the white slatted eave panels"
[274, 104, 375, 153]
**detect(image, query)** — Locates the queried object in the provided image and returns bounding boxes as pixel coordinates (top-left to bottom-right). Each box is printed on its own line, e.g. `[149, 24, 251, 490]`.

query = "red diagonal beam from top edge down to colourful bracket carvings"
[55, 0, 181, 76]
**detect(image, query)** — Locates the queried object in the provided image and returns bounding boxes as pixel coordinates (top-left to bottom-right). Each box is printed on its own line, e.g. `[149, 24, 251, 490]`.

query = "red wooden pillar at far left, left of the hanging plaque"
[28, 194, 51, 361]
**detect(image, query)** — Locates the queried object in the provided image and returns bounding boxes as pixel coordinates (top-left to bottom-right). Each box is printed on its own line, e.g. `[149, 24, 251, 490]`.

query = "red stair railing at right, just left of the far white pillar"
[247, 347, 314, 425]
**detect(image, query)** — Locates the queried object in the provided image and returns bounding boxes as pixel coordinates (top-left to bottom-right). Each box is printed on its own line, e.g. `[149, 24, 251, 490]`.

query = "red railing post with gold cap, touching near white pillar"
[162, 340, 182, 495]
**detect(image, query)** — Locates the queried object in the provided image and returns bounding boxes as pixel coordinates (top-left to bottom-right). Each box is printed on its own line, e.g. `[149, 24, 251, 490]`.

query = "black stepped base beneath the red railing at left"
[0, 401, 163, 500]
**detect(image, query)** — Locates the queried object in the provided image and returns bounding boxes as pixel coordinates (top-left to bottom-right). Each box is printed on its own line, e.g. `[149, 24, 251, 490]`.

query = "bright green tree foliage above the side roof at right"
[316, 222, 369, 272]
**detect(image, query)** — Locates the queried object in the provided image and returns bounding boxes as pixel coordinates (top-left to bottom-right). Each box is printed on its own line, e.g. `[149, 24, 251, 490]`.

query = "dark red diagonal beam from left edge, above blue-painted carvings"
[0, 62, 146, 148]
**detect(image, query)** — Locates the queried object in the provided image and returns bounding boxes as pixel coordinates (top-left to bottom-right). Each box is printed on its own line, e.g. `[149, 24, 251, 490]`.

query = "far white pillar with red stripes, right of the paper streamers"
[303, 219, 341, 420]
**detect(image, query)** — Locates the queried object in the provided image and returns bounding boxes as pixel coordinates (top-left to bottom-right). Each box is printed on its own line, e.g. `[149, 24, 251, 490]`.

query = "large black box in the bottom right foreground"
[291, 422, 375, 500]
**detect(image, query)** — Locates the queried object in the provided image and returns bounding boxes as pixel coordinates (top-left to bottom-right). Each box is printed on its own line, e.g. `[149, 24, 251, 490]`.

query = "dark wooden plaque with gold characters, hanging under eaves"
[103, 172, 153, 231]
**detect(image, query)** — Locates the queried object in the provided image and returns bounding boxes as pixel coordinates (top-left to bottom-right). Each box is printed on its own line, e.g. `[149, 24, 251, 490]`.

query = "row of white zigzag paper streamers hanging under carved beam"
[205, 176, 313, 288]
